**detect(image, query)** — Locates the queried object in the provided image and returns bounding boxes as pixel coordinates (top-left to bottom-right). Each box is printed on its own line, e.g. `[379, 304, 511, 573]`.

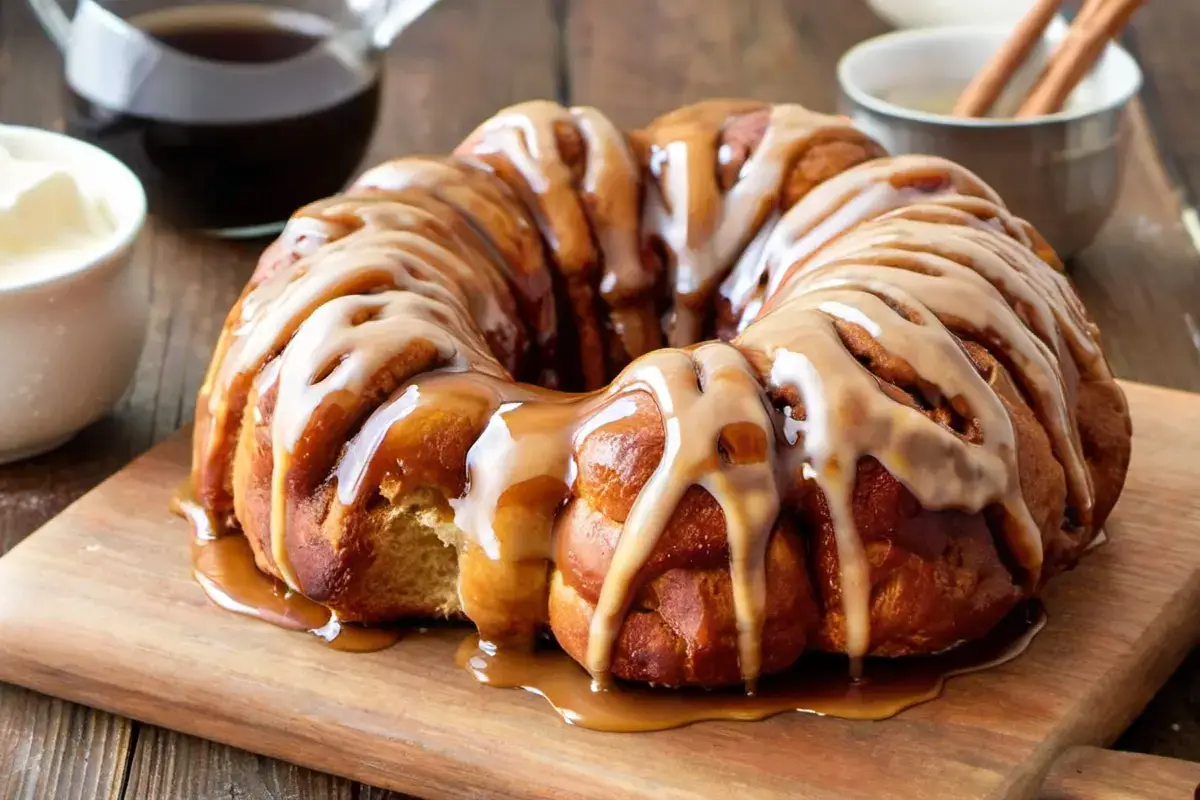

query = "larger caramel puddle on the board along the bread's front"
[457, 601, 1046, 733]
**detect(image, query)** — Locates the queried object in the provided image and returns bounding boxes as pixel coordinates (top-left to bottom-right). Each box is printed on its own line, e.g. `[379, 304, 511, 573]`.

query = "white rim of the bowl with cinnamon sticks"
[838, 25, 1144, 130]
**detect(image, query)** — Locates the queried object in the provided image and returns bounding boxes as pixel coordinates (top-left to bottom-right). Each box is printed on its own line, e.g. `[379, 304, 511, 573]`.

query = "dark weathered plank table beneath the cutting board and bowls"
[0, 0, 1200, 800]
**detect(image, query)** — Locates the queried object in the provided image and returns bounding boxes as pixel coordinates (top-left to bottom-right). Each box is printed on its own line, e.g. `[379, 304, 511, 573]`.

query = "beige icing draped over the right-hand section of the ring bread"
[736, 211, 1109, 655]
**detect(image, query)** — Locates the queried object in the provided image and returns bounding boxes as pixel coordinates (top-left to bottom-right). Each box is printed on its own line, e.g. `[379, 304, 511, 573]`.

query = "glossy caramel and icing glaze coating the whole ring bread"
[184, 101, 1110, 712]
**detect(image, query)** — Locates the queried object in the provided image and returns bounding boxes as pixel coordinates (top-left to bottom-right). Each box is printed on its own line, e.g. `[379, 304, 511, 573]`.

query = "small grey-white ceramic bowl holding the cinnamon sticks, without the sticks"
[838, 28, 1141, 258]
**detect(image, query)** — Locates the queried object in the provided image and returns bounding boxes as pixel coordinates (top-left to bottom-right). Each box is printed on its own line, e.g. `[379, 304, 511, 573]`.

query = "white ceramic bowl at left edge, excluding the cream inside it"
[0, 125, 149, 463]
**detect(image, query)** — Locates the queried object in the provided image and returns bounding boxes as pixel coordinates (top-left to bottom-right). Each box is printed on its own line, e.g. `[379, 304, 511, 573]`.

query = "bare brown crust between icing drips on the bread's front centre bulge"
[550, 503, 817, 686]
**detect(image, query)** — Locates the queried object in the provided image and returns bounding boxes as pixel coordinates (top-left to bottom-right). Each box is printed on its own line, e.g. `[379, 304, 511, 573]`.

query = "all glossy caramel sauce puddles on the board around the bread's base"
[172, 486, 1046, 733]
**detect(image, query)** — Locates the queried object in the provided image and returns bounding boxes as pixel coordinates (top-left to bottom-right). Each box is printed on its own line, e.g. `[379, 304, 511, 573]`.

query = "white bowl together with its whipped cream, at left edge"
[0, 125, 149, 463]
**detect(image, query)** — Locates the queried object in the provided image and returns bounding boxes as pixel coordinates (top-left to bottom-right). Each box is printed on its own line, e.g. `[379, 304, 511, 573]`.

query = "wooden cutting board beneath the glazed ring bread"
[0, 384, 1200, 798]
